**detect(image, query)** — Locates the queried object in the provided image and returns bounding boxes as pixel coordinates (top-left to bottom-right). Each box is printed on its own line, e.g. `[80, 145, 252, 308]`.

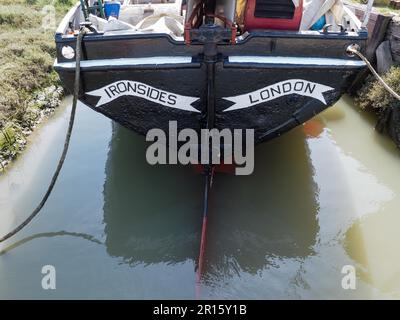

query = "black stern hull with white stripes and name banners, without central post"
[55, 33, 365, 143]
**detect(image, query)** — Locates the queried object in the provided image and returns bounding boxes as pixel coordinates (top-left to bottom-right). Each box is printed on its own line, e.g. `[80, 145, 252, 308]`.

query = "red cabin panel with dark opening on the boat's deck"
[244, 0, 303, 31]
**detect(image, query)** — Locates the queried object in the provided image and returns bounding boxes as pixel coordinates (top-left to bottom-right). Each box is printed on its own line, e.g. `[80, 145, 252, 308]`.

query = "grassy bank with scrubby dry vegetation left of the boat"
[0, 0, 75, 171]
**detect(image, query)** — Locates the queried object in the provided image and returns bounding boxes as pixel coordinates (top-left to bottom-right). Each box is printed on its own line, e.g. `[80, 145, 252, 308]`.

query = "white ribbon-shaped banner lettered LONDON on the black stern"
[223, 79, 334, 112]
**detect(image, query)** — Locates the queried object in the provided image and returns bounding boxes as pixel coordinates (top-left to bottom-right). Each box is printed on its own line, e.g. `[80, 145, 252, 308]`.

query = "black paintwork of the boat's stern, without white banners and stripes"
[56, 27, 367, 143]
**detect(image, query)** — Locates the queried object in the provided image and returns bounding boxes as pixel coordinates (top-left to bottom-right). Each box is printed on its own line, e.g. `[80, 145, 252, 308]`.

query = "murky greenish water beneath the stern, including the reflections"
[0, 97, 400, 299]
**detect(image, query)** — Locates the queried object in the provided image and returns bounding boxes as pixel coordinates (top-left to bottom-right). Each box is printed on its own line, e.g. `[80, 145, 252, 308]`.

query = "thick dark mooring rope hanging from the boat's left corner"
[0, 27, 88, 243]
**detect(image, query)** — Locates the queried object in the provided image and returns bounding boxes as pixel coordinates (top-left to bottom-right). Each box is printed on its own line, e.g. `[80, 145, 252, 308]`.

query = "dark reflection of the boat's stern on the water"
[104, 125, 318, 282]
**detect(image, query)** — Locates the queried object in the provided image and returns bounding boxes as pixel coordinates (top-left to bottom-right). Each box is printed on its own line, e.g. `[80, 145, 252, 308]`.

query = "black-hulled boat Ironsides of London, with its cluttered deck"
[54, 0, 368, 143]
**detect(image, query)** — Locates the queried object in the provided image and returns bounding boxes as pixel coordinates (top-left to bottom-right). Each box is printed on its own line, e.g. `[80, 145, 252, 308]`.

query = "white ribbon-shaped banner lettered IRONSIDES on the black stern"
[86, 80, 200, 112]
